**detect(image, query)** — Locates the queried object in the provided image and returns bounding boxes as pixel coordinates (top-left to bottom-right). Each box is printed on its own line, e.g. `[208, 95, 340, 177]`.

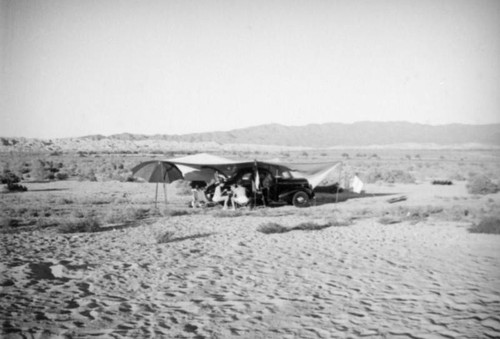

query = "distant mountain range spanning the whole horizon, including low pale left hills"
[0, 122, 500, 150]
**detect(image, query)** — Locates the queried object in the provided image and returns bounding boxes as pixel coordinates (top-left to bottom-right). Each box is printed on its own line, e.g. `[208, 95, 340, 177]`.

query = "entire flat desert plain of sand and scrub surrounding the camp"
[0, 150, 500, 338]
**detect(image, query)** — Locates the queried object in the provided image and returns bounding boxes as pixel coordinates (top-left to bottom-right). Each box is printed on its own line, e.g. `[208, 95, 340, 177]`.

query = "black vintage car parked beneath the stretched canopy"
[206, 166, 314, 207]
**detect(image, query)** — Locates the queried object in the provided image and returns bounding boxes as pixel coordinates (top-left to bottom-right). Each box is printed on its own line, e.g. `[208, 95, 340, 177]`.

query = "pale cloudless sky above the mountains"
[0, 0, 500, 138]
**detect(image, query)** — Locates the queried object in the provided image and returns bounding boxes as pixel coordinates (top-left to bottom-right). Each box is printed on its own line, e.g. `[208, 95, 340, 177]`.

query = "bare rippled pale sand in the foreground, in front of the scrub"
[0, 185, 500, 338]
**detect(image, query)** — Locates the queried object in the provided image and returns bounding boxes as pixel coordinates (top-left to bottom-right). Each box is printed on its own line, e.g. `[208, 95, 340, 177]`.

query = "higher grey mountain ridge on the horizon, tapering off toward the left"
[103, 122, 500, 147]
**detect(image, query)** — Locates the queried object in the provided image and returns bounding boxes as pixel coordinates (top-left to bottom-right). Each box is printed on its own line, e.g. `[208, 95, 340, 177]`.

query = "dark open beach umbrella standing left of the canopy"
[132, 160, 184, 207]
